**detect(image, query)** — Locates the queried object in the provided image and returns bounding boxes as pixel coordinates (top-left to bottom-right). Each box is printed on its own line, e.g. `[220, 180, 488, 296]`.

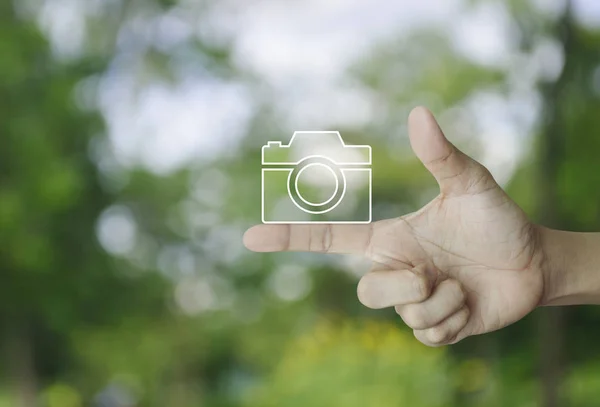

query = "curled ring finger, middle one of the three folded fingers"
[396, 279, 466, 329]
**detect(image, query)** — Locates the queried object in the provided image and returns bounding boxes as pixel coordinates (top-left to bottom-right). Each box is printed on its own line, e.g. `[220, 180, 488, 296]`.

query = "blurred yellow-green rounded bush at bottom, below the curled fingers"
[245, 320, 452, 407]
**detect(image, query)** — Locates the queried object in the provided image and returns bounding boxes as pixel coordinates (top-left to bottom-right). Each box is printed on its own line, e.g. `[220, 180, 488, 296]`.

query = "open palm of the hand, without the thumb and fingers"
[372, 187, 542, 335]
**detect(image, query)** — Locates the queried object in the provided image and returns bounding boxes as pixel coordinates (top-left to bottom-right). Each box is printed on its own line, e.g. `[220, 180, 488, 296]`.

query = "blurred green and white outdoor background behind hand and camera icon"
[0, 0, 600, 407]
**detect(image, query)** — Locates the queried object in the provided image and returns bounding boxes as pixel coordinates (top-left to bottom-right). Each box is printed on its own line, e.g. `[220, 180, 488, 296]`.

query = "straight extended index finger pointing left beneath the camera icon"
[244, 223, 375, 255]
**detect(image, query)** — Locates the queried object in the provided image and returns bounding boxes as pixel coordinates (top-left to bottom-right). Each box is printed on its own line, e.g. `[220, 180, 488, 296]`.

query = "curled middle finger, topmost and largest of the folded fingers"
[357, 266, 437, 309]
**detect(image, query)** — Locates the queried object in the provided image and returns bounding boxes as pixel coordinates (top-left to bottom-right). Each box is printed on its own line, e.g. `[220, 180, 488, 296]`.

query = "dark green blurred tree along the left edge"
[0, 2, 173, 407]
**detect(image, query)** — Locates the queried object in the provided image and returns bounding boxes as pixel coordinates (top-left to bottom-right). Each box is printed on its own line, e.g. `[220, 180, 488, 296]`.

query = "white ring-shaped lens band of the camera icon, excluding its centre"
[288, 157, 346, 215]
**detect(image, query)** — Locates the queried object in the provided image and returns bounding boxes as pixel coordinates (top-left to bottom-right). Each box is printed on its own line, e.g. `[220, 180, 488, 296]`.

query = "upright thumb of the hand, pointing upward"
[408, 107, 497, 195]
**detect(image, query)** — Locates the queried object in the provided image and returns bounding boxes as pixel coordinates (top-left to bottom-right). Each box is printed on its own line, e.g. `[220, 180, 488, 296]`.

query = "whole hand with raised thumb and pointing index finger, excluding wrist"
[244, 107, 544, 346]
